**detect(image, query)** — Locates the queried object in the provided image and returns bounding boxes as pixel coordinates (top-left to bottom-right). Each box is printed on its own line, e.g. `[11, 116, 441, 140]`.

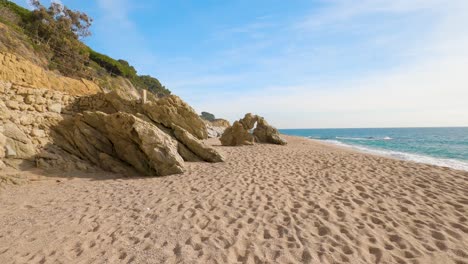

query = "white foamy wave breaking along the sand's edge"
[324, 140, 468, 171]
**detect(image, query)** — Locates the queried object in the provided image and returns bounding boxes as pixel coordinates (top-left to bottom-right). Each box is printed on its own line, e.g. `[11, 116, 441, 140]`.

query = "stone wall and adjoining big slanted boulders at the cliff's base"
[0, 81, 223, 176]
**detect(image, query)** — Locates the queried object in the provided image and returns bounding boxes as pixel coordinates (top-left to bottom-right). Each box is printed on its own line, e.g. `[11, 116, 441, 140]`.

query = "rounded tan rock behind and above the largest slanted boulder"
[143, 95, 208, 139]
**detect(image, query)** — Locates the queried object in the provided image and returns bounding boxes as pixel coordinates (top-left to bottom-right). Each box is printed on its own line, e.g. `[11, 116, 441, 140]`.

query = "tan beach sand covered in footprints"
[0, 137, 468, 264]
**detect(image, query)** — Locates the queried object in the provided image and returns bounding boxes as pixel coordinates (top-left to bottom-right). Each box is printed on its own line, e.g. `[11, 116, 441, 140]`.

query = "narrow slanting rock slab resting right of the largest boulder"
[174, 126, 224, 162]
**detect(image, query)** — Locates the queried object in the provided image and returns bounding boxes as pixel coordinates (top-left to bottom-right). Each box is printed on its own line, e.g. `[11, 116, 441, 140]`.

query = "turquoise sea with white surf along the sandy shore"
[280, 127, 468, 171]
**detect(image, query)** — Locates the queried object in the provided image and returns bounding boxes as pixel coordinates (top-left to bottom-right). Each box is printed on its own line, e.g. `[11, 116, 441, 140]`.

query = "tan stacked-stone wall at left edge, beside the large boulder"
[0, 81, 76, 165]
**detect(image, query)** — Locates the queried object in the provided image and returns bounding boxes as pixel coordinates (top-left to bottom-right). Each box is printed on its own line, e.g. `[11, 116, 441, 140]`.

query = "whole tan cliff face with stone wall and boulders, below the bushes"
[0, 16, 223, 176]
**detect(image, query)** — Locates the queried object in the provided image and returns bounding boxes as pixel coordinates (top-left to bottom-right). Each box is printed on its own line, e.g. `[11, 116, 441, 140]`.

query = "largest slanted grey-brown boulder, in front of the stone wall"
[57, 112, 183, 176]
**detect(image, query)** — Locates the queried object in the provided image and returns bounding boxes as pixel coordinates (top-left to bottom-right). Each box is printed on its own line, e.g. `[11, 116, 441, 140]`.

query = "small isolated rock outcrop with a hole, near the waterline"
[220, 113, 287, 146]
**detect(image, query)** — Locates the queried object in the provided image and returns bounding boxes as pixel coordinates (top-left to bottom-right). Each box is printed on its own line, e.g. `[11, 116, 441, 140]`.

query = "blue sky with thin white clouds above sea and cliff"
[11, 0, 468, 128]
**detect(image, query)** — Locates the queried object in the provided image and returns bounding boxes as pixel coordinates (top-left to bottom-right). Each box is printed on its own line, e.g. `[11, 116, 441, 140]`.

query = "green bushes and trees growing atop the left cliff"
[0, 0, 170, 96]
